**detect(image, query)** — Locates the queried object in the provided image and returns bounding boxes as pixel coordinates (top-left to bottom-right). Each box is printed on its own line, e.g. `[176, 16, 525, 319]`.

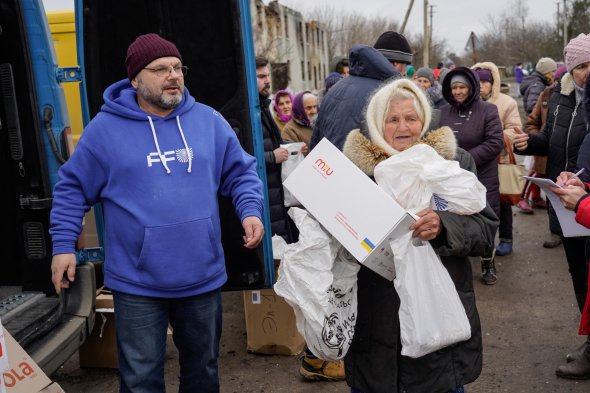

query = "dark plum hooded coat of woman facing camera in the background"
[440, 67, 504, 216]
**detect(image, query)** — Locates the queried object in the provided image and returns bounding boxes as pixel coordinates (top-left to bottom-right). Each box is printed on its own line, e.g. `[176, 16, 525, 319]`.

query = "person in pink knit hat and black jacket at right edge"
[514, 34, 590, 379]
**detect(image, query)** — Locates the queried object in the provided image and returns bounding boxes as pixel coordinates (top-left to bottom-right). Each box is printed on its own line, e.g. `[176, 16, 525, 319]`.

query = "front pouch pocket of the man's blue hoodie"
[137, 217, 223, 289]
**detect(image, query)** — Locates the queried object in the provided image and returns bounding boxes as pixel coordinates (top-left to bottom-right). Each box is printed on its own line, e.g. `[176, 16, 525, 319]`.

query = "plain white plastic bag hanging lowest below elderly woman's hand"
[391, 233, 471, 358]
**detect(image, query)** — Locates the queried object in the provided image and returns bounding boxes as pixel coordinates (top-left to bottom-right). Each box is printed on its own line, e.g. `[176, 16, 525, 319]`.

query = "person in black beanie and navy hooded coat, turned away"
[310, 31, 412, 150]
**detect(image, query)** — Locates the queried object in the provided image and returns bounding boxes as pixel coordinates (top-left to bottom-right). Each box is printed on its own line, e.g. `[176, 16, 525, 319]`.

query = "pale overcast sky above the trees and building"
[43, 0, 563, 54]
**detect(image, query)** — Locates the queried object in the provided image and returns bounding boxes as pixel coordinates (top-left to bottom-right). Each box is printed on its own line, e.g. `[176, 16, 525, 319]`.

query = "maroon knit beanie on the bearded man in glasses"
[125, 33, 182, 80]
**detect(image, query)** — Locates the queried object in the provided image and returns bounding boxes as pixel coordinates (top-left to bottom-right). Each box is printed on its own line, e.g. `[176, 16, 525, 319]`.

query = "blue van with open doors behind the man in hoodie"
[0, 0, 274, 374]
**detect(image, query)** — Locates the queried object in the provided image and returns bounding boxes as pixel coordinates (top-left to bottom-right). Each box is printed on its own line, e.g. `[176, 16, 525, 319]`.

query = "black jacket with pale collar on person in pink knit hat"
[514, 73, 590, 234]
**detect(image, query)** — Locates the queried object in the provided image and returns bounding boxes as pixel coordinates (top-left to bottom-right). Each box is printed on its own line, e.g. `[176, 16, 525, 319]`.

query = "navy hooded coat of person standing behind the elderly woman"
[310, 45, 400, 150]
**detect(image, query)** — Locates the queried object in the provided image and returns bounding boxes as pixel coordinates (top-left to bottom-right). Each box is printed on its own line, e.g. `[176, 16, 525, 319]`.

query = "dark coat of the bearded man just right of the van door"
[259, 96, 298, 243]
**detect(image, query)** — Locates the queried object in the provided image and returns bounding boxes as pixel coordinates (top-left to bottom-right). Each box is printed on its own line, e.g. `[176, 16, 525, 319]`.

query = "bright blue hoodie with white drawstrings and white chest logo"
[50, 79, 263, 298]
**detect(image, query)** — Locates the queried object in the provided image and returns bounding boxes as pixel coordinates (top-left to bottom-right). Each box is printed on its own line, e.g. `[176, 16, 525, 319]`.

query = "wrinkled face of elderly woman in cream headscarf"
[383, 99, 423, 151]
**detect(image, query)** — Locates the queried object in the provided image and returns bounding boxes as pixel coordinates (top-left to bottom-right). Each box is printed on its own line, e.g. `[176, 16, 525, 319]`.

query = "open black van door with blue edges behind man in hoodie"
[75, 0, 275, 290]
